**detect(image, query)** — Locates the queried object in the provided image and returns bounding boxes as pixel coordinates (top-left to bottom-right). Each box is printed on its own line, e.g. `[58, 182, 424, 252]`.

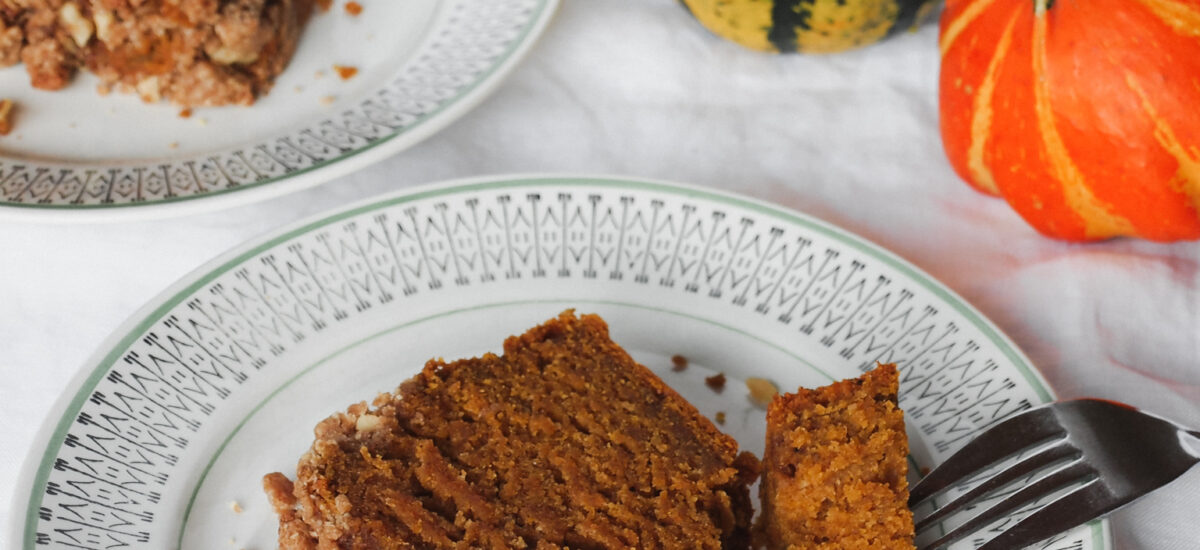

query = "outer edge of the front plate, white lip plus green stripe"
[10, 174, 1112, 550]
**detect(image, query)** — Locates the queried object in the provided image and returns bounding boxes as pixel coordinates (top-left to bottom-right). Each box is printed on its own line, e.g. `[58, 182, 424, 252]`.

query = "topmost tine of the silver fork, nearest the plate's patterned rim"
[908, 406, 1066, 508]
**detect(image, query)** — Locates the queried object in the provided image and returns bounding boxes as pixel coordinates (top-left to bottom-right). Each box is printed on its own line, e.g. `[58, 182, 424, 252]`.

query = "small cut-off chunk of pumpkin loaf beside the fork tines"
[760, 364, 913, 550]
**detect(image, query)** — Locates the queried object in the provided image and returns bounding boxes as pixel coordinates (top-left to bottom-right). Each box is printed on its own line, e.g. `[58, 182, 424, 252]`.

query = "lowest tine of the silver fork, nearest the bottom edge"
[978, 480, 1104, 550]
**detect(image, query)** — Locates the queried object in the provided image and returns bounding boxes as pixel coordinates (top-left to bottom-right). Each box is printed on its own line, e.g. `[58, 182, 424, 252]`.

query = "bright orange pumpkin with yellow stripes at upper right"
[940, 0, 1200, 241]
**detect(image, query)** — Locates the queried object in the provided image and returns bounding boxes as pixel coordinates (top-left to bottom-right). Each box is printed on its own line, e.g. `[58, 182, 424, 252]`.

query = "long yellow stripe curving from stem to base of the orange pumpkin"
[1031, 2, 1134, 239]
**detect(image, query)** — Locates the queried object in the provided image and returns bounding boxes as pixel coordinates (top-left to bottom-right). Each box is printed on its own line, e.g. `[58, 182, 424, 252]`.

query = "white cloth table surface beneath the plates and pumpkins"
[0, 0, 1200, 550]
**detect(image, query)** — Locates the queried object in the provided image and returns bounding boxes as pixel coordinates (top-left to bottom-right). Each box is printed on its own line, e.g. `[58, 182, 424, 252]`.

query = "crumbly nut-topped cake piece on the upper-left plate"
[0, 0, 329, 107]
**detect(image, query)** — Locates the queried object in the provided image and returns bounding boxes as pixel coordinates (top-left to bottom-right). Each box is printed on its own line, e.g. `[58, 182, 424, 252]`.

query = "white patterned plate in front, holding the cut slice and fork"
[6, 177, 1111, 550]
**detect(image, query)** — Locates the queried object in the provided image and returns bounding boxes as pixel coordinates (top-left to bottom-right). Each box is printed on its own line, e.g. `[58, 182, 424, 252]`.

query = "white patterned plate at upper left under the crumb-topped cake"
[0, 0, 559, 221]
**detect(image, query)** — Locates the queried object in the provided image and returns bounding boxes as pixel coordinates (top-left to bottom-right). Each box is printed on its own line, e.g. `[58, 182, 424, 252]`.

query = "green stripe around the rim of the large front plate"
[24, 175, 1108, 550]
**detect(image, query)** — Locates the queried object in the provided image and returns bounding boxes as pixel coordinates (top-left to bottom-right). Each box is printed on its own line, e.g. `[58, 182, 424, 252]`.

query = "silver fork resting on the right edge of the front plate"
[908, 399, 1200, 550]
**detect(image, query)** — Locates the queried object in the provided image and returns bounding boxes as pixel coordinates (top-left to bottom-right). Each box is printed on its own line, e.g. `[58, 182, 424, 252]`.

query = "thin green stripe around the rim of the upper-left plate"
[0, 0, 558, 210]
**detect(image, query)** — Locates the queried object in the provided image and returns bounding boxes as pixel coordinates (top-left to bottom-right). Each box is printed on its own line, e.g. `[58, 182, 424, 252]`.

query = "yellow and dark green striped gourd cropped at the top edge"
[680, 0, 936, 53]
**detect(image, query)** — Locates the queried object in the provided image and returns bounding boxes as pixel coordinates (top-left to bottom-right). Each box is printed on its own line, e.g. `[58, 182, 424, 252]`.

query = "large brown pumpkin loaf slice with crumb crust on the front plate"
[263, 311, 758, 550]
